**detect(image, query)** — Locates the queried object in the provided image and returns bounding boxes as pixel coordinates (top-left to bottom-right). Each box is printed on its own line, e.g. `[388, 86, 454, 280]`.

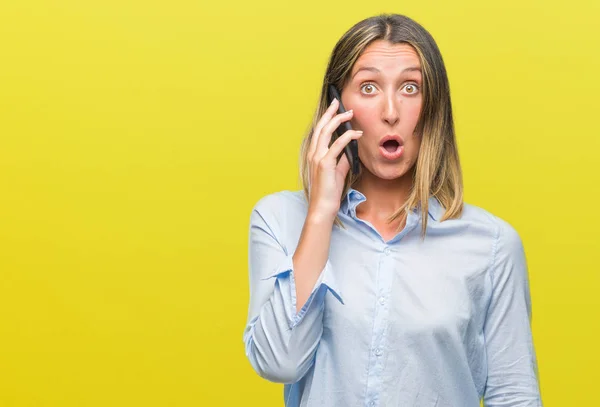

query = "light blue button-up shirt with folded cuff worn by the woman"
[243, 189, 542, 407]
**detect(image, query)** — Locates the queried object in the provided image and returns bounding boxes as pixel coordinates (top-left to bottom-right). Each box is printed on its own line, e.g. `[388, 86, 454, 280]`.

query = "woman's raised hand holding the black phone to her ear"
[307, 99, 362, 222]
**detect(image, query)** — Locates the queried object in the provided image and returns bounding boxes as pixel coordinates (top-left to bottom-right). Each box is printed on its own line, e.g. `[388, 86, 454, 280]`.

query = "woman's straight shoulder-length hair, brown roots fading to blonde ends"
[300, 14, 463, 239]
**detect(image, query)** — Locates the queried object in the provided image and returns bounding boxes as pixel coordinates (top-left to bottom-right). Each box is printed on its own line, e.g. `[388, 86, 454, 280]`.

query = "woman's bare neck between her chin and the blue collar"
[353, 168, 413, 219]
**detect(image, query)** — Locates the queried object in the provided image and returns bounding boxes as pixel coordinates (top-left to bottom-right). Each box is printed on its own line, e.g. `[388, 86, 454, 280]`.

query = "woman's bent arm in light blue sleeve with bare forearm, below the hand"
[239, 196, 342, 383]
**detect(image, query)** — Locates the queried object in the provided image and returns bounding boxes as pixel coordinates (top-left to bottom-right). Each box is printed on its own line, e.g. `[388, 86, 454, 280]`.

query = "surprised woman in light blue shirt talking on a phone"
[244, 15, 542, 407]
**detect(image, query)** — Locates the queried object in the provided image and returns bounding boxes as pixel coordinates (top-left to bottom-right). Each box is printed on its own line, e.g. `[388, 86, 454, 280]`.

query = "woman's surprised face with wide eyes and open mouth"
[341, 40, 422, 180]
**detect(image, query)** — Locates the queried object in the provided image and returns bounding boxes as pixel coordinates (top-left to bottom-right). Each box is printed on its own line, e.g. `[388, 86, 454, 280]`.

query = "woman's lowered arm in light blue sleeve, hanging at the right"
[483, 219, 542, 407]
